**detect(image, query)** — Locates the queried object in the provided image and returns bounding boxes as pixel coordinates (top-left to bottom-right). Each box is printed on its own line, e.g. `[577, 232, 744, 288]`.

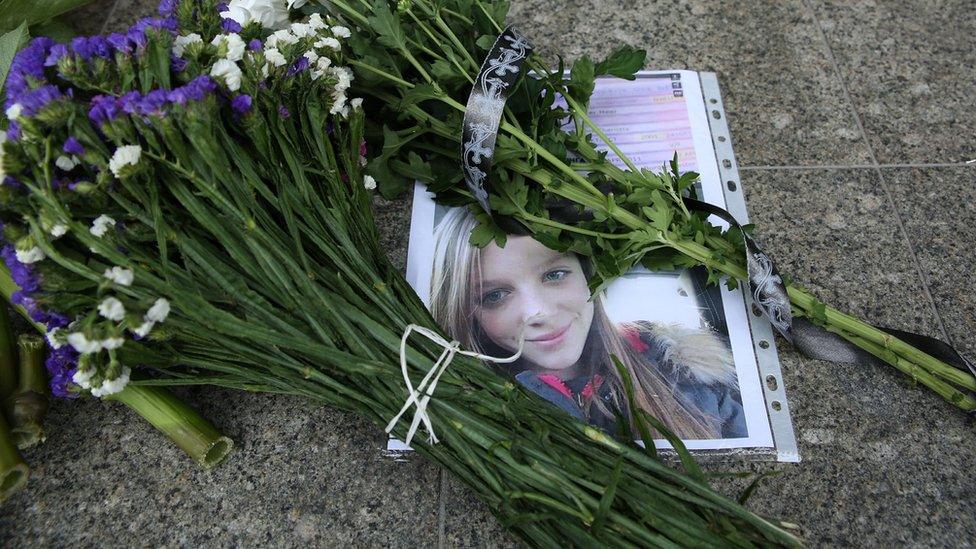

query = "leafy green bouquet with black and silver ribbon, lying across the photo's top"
[318, 0, 976, 412]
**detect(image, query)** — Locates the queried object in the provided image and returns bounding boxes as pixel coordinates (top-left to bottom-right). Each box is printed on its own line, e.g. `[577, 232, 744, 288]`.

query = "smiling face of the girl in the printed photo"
[474, 236, 593, 373]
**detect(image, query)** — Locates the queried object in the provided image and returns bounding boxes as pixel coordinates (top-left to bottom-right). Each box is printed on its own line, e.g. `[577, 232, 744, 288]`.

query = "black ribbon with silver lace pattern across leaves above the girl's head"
[461, 27, 532, 215]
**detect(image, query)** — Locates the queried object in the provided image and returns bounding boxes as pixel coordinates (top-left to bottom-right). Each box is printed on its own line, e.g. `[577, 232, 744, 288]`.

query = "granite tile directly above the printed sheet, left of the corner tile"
[509, 0, 869, 165]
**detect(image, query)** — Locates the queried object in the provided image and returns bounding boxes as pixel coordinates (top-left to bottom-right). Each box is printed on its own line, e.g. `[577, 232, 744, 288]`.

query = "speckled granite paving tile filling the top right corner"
[813, 0, 976, 164]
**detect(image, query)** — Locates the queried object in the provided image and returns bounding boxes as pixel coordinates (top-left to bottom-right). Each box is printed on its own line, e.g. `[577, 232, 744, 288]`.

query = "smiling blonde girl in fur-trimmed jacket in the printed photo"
[429, 208, 748, 440]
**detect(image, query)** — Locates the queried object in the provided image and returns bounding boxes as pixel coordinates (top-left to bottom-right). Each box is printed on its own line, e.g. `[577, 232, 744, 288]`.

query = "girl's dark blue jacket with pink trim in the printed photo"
[515, 322, 748, 438]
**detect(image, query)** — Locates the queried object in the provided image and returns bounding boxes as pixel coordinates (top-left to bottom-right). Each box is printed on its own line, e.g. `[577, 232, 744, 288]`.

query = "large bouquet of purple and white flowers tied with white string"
[2, 0, 798, 546]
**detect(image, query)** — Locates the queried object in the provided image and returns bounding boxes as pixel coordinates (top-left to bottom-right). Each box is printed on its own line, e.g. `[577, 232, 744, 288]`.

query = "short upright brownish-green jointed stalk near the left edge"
[4, 334, 49, 450]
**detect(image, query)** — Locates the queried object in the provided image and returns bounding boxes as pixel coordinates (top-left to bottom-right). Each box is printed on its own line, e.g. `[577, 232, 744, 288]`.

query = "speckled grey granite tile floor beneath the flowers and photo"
[0, 0, 976, 547]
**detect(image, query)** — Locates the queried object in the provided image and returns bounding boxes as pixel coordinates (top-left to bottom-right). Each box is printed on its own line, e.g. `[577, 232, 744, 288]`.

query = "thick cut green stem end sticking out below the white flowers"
[105, 383, 234, 469]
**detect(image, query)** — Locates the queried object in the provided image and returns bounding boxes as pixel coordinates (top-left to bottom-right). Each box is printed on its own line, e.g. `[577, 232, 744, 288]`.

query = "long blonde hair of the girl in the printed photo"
[430, 208, 735, 439]
